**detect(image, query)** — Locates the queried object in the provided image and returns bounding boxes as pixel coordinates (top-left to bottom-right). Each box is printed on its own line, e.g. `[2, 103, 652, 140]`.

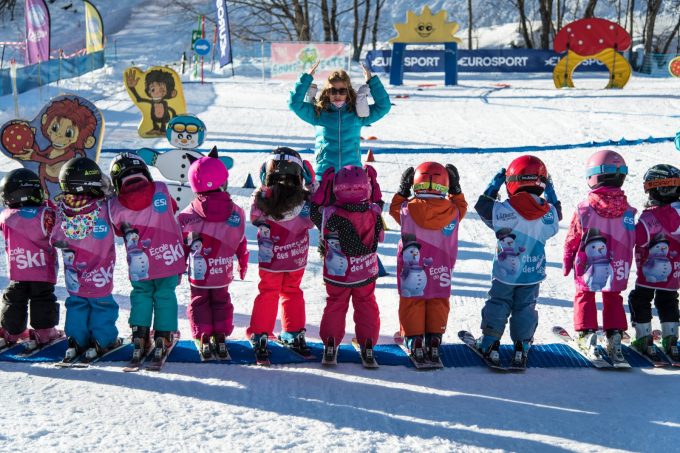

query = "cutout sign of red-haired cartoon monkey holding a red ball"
[0, 95, 104, 200]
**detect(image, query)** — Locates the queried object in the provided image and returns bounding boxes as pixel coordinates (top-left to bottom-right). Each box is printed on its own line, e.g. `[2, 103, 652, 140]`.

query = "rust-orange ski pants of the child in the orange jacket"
[399, 297, 449, 337]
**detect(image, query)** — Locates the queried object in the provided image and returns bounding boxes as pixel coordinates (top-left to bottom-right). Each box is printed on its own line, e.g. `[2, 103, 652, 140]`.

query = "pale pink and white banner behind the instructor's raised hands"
[271, 42, 348, 80]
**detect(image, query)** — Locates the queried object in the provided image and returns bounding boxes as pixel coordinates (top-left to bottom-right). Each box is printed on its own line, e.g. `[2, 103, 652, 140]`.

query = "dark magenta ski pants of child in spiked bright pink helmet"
[187, 286, 234, 339]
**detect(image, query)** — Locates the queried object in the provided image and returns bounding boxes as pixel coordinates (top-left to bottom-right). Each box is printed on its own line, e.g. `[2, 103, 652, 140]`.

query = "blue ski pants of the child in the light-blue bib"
[481, 279, 540, 342]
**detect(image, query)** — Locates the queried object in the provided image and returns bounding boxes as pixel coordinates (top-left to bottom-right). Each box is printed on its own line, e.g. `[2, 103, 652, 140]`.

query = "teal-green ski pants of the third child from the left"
[128, 275, 179, 332]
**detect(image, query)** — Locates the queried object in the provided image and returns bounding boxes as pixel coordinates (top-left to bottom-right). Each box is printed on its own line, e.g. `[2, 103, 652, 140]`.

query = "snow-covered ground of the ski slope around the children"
[0, 2, 680, 452]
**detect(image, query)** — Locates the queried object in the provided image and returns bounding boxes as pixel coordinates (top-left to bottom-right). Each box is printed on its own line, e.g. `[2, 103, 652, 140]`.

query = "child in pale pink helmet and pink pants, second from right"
[563, 150, 636, 363]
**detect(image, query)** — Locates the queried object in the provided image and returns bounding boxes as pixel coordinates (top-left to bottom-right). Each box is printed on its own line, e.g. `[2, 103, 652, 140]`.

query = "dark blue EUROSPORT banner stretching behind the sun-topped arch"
[366, 49, 607, 73]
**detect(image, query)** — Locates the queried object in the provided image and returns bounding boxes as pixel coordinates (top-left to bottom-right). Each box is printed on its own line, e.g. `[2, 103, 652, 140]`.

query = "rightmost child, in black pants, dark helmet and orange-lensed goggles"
[628, 164, 680, 362]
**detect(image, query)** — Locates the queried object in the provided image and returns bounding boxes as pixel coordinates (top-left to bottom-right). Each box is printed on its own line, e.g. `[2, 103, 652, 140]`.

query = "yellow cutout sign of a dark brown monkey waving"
[124, 66, 186, 138]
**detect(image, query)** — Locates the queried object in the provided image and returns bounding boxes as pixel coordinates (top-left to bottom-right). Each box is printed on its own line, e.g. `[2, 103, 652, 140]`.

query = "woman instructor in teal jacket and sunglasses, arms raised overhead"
[288, 61, 392, 175]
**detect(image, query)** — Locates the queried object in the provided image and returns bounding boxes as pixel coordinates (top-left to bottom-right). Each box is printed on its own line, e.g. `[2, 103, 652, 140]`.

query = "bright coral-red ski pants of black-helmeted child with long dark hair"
[246, 269, 306, 337]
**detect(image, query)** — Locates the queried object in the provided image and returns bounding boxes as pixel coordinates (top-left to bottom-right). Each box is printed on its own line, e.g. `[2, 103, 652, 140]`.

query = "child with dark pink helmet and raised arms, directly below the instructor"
[311, 165, 384, 363]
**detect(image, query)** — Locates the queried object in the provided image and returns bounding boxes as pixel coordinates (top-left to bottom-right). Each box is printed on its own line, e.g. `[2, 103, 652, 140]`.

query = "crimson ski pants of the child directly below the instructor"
[319, 282, 380, 345]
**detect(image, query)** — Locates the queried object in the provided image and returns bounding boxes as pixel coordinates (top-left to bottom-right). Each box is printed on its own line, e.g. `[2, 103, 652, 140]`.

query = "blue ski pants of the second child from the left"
[64, 294, 118, 348]
